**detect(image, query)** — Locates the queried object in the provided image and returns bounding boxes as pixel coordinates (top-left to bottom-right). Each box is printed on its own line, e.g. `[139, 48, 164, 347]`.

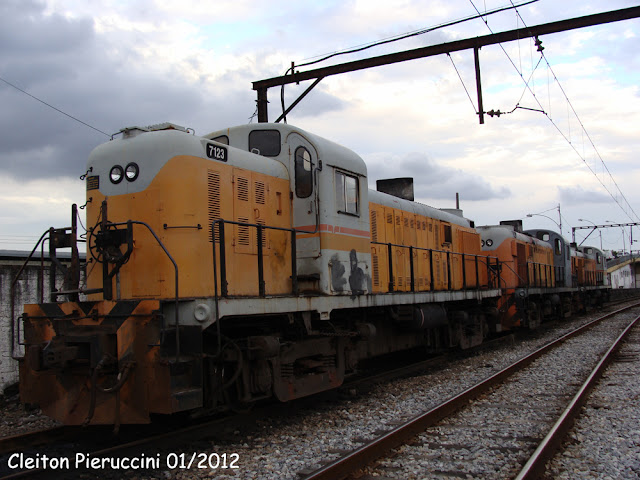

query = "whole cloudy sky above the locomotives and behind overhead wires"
[0, 0, 640, 250]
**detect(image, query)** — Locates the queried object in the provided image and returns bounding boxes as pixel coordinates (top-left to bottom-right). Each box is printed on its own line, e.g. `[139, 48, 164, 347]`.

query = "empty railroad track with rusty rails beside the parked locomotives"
[300, 307, 640, 480]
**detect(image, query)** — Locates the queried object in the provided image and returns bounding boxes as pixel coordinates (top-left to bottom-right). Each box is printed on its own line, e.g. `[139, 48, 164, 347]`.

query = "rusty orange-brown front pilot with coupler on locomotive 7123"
[20, 300, 164, 425]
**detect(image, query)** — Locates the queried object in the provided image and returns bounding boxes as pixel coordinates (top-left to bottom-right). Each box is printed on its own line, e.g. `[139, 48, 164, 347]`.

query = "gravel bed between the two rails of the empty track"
[370, 314, 632, 479]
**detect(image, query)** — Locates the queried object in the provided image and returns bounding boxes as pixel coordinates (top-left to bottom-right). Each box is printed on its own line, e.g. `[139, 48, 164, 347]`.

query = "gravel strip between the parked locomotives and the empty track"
[148, 310, 640, 479]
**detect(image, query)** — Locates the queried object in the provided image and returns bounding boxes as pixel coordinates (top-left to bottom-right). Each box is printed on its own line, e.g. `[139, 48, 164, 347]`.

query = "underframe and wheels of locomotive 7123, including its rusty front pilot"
[20, 292, 495, 424]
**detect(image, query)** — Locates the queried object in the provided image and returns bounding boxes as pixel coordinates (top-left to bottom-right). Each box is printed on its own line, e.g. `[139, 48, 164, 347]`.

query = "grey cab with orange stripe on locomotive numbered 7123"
[205, 123, 371, 295]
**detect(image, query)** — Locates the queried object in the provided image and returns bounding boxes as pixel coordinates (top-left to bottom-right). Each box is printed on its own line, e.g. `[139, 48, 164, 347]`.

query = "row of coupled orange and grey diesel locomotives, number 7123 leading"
[12, 123, 607, 425]
